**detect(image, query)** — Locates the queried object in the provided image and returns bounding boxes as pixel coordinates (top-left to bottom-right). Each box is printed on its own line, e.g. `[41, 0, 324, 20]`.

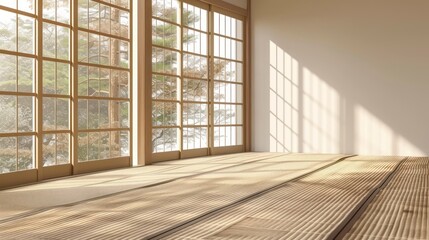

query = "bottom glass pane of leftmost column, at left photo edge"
[0, 137, 17, 173]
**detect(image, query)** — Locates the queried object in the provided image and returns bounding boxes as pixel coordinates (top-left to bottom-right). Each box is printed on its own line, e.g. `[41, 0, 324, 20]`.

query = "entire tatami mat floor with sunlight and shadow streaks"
[0, 153, 429, 240]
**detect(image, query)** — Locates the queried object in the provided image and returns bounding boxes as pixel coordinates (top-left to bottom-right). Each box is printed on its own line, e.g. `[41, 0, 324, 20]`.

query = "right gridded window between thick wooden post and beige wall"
[152, 0, 244, 158]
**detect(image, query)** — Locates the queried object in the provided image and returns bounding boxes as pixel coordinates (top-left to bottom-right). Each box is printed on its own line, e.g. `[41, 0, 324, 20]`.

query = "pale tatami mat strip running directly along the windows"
[0, 153, 278, 221]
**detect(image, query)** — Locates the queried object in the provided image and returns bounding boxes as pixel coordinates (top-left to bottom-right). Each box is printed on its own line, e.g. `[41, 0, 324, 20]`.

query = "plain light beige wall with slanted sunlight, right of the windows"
[252, 0, 429, 155]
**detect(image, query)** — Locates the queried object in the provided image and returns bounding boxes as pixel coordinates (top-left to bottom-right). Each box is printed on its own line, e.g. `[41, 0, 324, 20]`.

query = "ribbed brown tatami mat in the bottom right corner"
[345, 158, 429, 240]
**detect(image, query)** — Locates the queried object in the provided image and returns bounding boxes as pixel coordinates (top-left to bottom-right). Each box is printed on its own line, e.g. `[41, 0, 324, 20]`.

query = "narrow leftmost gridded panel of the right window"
[152, 0, 182, 153]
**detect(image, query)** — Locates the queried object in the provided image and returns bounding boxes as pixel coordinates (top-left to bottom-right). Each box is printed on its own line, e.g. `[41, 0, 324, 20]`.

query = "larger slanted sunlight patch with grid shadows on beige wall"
[270, 41, 340, 153]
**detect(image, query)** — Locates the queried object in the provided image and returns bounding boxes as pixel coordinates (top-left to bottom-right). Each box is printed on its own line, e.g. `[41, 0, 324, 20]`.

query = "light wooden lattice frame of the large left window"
[0, 0, 134, 189]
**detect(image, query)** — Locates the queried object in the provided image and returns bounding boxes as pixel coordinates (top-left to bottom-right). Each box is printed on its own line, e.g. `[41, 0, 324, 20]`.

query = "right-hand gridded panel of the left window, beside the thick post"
[77, 0, 131, 162]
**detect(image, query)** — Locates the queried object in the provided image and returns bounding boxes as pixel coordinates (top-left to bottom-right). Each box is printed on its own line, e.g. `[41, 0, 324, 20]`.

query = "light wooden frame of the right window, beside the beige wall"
[143, 0, 251, 165]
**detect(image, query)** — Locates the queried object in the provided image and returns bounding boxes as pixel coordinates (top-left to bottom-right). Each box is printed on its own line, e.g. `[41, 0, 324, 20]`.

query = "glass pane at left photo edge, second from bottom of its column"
[0, 95, 17, 133]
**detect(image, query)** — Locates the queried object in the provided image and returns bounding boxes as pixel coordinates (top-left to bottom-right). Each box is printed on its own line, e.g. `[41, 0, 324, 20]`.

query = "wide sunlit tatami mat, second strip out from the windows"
[0, 153, 344, 239]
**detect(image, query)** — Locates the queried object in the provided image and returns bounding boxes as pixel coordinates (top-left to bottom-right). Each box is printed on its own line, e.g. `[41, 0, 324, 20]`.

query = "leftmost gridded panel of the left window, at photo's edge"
[0, 1, 37, 174]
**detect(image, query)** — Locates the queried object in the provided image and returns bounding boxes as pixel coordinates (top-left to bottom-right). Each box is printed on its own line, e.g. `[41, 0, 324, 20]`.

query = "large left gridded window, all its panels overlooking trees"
[0, 0, 132, 183]
